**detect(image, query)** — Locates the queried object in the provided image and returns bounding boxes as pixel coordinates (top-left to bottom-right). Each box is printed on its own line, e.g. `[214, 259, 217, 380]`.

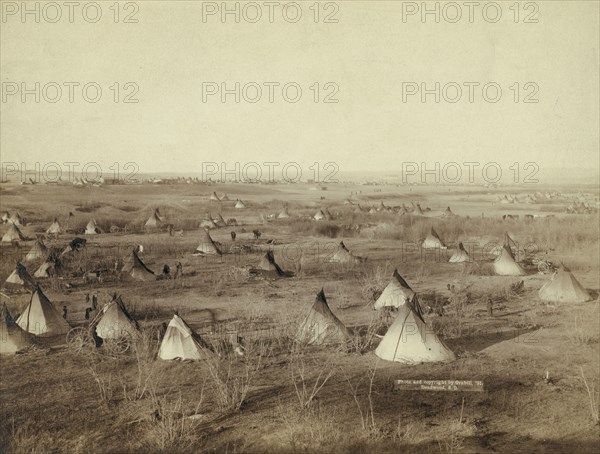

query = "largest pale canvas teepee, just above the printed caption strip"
[375, 304, 455, 363]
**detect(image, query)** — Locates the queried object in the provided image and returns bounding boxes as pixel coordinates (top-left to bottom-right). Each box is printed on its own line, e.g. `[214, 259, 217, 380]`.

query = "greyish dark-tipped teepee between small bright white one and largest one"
[297, 289, 350, 344]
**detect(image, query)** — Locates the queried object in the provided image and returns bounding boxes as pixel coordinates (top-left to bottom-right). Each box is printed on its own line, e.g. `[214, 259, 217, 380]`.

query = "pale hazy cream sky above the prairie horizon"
[0, 1, 600, 173]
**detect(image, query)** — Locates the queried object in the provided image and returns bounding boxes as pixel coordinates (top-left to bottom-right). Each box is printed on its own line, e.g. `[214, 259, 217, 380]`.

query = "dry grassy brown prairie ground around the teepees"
[0, 183, 600, 453]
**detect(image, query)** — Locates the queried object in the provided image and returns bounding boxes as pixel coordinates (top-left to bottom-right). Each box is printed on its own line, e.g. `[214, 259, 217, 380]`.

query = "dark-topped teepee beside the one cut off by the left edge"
[17, 287, 71, 337]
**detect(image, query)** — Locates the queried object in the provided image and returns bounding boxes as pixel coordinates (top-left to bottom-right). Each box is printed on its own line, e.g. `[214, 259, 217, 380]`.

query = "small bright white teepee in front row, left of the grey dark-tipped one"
[158, 315, 205, 360]
